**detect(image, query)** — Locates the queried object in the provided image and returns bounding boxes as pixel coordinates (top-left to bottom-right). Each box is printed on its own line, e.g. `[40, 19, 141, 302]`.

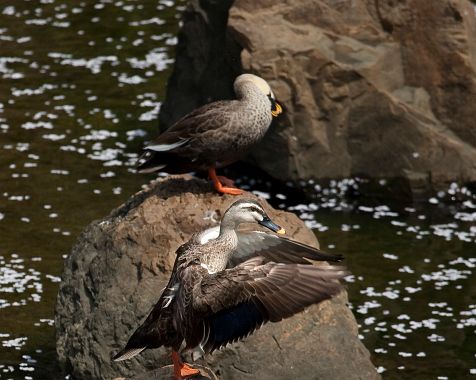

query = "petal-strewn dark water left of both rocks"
[0, 0, 180, 379]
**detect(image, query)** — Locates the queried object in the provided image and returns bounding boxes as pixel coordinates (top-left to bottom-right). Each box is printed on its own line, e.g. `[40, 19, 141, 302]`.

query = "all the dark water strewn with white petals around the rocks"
[0, 0, 476, 379]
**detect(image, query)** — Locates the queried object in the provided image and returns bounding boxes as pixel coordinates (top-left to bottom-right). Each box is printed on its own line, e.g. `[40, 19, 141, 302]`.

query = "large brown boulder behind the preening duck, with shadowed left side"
[161, 0, 476, 191]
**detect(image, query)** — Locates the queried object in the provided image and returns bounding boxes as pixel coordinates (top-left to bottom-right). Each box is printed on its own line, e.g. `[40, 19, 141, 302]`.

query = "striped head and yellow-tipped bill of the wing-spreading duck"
[221, 199, 286, 234]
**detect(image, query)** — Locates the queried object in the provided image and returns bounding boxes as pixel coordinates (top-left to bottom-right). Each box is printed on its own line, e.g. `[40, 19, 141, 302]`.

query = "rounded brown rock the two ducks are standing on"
[55, 178, 379, 380]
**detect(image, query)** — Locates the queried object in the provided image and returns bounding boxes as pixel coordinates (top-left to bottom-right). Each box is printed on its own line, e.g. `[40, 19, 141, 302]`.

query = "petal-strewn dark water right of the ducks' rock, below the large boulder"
[272, 179, 476, 378]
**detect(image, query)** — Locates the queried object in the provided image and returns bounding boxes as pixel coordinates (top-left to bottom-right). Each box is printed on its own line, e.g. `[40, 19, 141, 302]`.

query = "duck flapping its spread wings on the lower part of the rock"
[113, 198, 347, 380]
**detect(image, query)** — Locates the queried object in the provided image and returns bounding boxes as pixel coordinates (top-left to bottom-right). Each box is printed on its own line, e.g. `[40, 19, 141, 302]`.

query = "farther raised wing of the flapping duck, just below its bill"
[229, 231, 343, 266]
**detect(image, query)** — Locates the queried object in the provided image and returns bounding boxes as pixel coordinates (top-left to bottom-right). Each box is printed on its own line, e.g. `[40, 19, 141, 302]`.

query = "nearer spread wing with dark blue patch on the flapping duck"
[193, 257, 347, 354]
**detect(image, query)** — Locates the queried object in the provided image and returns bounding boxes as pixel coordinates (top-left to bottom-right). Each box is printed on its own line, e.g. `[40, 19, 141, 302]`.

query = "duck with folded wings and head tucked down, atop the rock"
[136, 74, 283, 195]
